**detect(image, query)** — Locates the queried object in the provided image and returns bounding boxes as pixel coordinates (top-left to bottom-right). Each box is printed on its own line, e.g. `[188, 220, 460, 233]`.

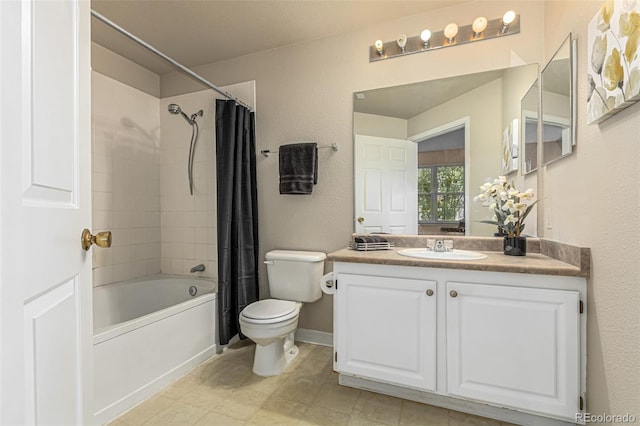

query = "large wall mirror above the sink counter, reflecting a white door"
[353, 64, 538, 236]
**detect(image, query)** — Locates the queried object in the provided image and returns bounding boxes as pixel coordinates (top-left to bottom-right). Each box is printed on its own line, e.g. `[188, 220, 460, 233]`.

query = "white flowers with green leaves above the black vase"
[474, 176, 538, 237]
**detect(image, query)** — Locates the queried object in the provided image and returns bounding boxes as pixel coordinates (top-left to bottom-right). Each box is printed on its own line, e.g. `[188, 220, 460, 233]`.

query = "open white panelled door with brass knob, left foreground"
[0, 0, 93, 425]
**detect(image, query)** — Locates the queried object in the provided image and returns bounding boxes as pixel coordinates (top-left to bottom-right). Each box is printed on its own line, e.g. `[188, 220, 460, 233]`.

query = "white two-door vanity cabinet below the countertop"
[334, 262, 586, 424]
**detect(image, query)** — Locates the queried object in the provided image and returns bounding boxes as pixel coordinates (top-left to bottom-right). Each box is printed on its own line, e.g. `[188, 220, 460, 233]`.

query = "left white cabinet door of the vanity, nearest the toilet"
[334, 274, 436, 391]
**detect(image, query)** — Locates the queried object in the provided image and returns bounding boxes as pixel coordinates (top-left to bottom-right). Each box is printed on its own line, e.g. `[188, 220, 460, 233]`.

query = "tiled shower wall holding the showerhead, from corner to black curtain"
[160, 90, 218, 277]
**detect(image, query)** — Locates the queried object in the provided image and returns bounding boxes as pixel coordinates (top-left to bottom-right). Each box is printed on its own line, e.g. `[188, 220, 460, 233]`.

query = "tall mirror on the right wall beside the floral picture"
[541, 34, 576, 165]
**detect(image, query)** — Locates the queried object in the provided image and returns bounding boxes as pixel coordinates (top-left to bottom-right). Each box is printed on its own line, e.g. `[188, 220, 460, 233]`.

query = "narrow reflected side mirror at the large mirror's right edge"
[520, 80, 540, 174]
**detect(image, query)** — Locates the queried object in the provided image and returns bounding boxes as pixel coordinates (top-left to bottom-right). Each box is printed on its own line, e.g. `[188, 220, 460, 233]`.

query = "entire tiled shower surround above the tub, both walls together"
[92, 72, 255, 286]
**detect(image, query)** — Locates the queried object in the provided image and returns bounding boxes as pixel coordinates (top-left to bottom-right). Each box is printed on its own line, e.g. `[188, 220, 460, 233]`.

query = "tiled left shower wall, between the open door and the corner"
[92, 72, 161, 286]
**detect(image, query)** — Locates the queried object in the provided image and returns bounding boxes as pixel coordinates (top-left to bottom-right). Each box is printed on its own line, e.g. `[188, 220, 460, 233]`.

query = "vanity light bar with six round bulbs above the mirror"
[369, 10, 520, 62]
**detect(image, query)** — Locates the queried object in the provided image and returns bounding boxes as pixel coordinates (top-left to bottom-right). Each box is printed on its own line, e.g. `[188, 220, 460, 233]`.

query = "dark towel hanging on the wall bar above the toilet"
[278, 142, 318, 194]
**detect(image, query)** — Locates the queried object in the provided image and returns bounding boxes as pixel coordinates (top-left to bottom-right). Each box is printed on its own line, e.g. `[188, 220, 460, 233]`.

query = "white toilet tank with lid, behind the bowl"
[265, 250, 327, 302]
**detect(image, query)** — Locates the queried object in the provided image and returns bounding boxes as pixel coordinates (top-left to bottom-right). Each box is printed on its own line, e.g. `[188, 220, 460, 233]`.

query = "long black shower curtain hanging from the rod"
[216, 100, 258, 345]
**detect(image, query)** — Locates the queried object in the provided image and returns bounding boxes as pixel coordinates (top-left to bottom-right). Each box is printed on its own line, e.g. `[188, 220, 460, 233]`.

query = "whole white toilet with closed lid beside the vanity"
[239, 250, 327, 376]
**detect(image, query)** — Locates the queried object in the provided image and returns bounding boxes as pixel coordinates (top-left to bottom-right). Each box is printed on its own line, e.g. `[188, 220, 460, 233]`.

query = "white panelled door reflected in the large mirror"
[355, 135, 418, 234]
